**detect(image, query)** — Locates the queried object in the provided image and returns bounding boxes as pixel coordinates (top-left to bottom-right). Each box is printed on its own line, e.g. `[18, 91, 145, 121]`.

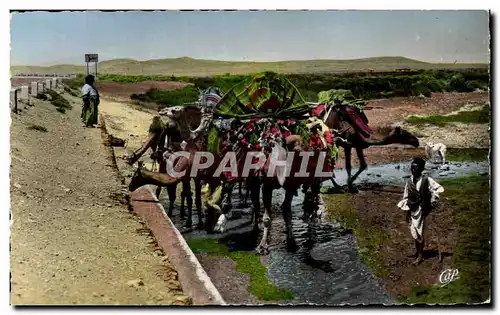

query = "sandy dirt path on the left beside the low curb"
[11, 95, 188, 305]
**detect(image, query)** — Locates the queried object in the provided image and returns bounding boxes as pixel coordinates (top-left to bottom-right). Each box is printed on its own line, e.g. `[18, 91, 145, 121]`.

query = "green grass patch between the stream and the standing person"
[323, 194, 390, 277]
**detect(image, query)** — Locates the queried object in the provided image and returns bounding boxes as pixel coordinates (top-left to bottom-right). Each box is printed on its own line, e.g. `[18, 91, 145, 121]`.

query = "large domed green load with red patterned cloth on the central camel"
[202, 72, 338, 183]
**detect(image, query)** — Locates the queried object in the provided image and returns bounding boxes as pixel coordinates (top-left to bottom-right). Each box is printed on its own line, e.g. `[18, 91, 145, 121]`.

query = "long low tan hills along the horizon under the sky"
[11, 57, 488, 76]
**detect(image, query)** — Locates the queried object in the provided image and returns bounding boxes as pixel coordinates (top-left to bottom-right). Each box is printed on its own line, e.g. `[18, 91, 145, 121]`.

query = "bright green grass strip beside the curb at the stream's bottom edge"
[186, 238, 294, 301]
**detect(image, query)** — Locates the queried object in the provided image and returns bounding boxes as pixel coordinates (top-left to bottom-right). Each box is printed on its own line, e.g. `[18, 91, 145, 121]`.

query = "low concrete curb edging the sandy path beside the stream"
[101, 115, 227, 305]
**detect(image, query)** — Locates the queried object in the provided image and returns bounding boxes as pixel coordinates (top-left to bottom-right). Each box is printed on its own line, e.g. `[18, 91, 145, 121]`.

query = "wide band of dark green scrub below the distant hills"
[98, 65, 490, 105]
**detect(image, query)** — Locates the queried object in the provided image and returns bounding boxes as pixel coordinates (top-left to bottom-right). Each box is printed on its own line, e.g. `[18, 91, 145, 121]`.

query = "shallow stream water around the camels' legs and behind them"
[161, 162, 489, 305]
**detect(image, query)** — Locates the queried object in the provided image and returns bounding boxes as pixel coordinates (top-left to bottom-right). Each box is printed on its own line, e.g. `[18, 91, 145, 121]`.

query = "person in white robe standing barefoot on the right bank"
[398, 158, 444, 265]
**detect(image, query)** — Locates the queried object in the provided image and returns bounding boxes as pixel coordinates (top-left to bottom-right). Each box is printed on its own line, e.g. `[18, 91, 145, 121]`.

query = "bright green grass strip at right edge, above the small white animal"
[406, 105, 491, 127]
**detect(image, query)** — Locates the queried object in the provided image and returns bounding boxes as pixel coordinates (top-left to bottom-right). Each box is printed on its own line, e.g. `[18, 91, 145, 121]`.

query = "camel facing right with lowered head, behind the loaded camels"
[323, 106, 419, 191]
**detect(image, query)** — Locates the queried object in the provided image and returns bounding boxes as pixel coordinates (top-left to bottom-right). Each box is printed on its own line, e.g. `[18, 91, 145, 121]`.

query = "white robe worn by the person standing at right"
[398, 176, 444, 240]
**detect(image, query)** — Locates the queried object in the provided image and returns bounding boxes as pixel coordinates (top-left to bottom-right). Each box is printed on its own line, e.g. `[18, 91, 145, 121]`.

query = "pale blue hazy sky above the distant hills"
[11, 11, 489, 65]
